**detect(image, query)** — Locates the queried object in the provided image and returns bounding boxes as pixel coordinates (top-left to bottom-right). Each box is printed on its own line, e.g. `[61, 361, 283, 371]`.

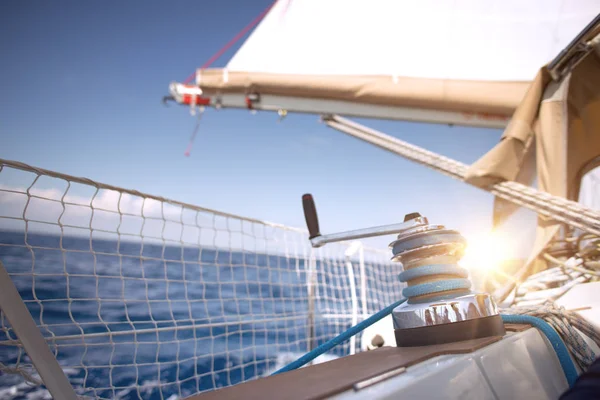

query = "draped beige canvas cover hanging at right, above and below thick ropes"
[486, 31, 600, 298]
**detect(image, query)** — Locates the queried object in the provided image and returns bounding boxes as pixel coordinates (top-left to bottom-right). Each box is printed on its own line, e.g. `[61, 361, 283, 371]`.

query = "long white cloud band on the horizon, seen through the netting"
[0, 185, 307, 252]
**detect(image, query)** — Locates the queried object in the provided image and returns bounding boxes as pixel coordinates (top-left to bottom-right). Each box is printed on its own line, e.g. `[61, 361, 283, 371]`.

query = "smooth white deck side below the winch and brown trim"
[333, 328, 568, 400]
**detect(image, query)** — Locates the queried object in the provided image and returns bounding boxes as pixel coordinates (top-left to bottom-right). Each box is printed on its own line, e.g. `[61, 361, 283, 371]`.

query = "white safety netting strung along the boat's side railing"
[0, 160, 401, 400]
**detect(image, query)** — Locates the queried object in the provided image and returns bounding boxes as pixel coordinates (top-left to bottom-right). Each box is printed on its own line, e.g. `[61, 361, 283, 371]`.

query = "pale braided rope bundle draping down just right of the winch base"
[501, 302, 600, 371]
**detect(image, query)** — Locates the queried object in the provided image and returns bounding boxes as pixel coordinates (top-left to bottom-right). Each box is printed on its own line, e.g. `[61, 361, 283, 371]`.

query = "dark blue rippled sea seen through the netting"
[0, 231, 372, 400]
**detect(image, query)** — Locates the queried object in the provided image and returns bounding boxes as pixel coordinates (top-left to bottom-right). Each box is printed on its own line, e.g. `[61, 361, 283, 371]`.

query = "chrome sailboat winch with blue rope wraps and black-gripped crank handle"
[302, 194, 505, 347]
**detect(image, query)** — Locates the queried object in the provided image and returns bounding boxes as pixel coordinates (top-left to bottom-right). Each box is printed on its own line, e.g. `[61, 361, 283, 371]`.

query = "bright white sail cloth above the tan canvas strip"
[227, 0, 600, 82]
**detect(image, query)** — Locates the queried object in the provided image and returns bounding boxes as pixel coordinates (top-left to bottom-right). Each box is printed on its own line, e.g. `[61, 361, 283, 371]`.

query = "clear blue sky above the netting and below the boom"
[0, 0, 536, 255]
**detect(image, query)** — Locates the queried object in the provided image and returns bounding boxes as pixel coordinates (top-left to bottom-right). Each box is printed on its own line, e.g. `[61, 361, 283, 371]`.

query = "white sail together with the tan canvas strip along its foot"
[197, 0, 600, 122]
